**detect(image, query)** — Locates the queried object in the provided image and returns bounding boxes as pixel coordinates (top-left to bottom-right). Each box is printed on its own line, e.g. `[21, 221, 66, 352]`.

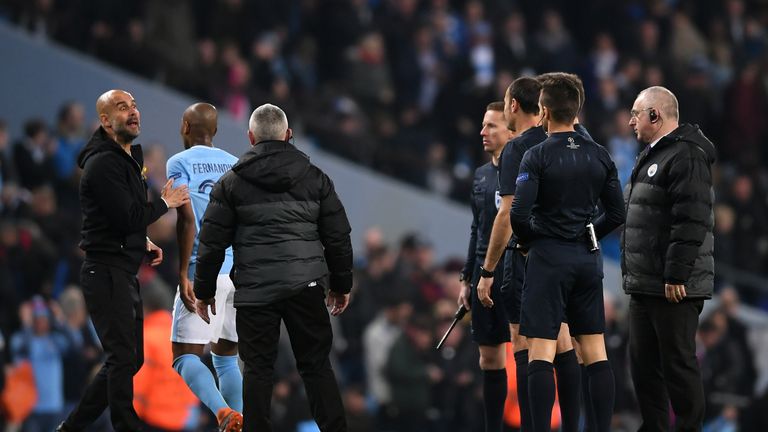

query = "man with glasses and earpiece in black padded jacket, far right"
[621, 87, 715, 431]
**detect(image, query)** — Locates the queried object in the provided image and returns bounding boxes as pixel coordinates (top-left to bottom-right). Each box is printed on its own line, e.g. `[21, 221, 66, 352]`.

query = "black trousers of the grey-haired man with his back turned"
[236, 286, 347, 432]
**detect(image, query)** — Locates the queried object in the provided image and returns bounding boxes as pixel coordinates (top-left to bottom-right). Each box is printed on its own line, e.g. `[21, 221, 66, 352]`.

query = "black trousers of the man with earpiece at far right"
[629, 295, 704, 431]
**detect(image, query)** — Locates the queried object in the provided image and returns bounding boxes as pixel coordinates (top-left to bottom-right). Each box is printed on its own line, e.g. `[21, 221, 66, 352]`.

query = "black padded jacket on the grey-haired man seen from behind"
[194, 141, 352, 306]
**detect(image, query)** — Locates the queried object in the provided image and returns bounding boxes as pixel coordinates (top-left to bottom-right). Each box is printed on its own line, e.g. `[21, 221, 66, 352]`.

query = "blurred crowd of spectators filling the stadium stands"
[0, 0, 768, 431]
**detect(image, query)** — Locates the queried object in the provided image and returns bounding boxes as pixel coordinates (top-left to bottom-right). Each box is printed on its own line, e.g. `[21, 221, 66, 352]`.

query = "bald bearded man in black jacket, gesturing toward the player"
[57, 90, 189, 432]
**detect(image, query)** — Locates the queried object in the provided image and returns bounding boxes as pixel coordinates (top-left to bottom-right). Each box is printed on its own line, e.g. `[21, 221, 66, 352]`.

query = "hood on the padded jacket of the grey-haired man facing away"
[232, 141, 311, 192]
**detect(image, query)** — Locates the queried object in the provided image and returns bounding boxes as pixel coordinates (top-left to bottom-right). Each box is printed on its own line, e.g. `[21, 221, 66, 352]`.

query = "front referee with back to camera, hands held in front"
[511, 77, 624, 431]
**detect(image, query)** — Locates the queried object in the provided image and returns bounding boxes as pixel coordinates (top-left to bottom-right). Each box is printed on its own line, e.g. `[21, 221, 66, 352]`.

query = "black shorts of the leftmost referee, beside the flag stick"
[470, 257, 510, 345]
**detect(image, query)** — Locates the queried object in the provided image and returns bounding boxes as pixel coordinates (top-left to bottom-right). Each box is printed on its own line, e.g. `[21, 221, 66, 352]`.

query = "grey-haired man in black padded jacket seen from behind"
[194, 104, 352, 432]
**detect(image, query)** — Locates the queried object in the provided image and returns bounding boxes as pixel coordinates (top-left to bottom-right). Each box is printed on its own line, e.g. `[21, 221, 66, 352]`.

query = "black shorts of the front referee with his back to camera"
[520, 239, 605, 340]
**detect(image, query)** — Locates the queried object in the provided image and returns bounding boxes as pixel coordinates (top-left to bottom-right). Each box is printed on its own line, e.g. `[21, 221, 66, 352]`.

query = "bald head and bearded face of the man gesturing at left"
[96, 90, 141, 145]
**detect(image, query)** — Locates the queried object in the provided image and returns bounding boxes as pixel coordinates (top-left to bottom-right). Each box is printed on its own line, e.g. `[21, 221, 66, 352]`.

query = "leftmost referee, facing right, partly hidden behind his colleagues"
[459, 102, 512, 432]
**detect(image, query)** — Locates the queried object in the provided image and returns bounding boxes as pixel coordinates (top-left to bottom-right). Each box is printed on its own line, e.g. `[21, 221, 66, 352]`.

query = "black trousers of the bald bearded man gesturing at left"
[65, 261, 144, 432]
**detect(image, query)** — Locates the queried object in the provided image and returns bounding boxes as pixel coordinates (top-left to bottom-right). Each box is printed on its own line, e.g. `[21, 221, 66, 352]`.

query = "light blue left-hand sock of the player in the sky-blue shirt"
[173, 354, 230, 415]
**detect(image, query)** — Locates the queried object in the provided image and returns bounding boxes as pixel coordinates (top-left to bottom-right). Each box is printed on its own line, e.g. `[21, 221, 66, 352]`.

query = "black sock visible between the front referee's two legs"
[554, 350, 581, 432]
